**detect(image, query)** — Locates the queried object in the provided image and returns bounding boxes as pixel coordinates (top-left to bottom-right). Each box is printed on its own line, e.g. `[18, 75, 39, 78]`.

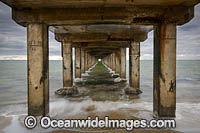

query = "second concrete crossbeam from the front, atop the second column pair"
[53, 24, 153, 42]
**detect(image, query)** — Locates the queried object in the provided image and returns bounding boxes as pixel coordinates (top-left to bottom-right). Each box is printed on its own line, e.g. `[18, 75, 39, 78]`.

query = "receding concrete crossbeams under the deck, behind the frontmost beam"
[54, 24, 152, 60]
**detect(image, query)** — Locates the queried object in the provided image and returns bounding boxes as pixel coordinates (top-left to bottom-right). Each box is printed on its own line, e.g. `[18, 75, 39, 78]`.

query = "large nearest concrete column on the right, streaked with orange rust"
[153, 23, 176, 117]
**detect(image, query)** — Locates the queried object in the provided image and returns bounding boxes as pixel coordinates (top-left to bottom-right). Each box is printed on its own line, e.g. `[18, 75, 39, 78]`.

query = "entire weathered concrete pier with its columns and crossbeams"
[1, 0, 199, 117]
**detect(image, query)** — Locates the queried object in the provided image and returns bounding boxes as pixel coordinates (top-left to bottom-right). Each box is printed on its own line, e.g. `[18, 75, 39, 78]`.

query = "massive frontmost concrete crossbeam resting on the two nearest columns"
[12, 5, 195, 26]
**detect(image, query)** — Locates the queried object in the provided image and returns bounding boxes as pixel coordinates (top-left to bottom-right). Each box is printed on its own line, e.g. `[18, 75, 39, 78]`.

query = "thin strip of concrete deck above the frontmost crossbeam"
[1, 0, 198, 9]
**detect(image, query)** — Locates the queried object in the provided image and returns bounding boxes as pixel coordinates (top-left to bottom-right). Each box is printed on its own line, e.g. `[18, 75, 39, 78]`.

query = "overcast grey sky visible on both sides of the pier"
[0, 2, 200, 59]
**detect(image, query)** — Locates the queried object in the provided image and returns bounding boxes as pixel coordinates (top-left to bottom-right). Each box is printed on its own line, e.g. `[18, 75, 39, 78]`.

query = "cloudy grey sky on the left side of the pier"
[0, 2, 61, 60]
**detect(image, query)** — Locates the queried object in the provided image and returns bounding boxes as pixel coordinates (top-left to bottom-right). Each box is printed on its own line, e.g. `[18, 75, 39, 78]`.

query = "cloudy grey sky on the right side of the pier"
[141, 4, 200, 60]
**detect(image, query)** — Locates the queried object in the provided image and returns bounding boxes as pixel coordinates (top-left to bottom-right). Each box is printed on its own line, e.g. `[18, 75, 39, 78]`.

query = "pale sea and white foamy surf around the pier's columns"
[0, 60, 200, 132]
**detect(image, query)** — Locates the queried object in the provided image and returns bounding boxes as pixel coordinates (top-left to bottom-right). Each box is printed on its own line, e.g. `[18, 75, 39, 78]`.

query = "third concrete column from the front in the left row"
[75, 47, 81, 78]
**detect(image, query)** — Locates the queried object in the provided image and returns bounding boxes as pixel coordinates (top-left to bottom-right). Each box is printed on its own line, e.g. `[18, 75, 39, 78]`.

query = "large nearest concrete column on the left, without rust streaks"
[27, 23, 49, 116]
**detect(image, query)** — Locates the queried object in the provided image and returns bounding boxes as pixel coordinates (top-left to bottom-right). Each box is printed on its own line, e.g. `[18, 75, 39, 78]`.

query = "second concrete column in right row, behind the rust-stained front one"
[129, 42, 140, 90]
